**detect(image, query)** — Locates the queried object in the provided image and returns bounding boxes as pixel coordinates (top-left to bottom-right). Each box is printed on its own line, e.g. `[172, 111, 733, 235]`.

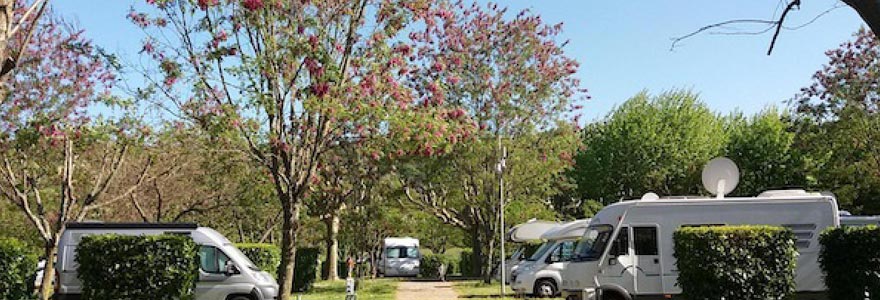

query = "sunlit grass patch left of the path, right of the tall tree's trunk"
[294, 279, 397, 300]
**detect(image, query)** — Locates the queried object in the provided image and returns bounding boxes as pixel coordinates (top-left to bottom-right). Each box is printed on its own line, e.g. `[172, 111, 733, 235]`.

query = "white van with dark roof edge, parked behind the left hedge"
[55, 223, 278, 300]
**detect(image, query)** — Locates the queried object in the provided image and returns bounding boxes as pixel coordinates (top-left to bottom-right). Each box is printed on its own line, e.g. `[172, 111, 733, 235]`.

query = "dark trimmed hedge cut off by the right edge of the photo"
[819, 226, 880, 300]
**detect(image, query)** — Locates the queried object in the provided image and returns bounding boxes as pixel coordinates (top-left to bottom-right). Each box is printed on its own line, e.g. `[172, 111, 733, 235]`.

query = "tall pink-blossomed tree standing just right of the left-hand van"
[129, 0, 471, 299]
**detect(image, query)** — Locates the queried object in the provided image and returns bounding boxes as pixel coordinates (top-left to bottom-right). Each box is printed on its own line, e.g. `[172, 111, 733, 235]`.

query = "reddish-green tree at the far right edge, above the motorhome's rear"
[792, 29, 880, 214]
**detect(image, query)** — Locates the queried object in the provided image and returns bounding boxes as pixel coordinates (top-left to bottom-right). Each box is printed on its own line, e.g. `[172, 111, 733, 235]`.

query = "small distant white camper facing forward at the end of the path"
[378, 237, 422, 277]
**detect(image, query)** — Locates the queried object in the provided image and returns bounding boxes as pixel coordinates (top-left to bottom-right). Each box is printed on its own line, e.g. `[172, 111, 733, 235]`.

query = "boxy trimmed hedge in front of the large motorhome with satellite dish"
[674, 226, 797, 300]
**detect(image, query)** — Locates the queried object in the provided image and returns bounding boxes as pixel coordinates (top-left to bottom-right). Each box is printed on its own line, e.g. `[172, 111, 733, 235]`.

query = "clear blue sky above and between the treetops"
[52, 0, 862, 120]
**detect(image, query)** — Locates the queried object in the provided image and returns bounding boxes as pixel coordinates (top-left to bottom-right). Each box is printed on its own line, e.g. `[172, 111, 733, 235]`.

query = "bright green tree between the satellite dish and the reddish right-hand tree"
[725, 108, 807, 196]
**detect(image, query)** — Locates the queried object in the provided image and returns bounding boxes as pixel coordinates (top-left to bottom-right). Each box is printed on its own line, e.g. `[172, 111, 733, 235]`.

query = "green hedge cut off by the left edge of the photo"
[0, 238, 37, 300]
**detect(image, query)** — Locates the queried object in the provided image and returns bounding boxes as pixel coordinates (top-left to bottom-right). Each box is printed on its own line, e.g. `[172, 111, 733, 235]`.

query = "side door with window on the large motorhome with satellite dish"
[632, 225, 663, 295]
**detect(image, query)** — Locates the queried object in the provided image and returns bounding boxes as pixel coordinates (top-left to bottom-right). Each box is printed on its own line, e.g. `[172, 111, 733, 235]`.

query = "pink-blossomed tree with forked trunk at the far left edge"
[0, 11, 149, 299]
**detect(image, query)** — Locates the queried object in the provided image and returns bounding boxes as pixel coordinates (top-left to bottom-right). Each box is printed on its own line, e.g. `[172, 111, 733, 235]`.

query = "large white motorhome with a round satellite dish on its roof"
[562, 160, 840, 300]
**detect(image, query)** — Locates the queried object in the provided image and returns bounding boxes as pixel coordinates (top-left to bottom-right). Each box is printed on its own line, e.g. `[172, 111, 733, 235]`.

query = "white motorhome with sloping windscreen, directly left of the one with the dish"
[510, 219, 590, 297]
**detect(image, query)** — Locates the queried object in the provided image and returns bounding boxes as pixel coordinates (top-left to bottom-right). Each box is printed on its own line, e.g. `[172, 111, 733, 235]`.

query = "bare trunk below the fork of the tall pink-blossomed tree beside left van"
[278, 199, 301, 300]
